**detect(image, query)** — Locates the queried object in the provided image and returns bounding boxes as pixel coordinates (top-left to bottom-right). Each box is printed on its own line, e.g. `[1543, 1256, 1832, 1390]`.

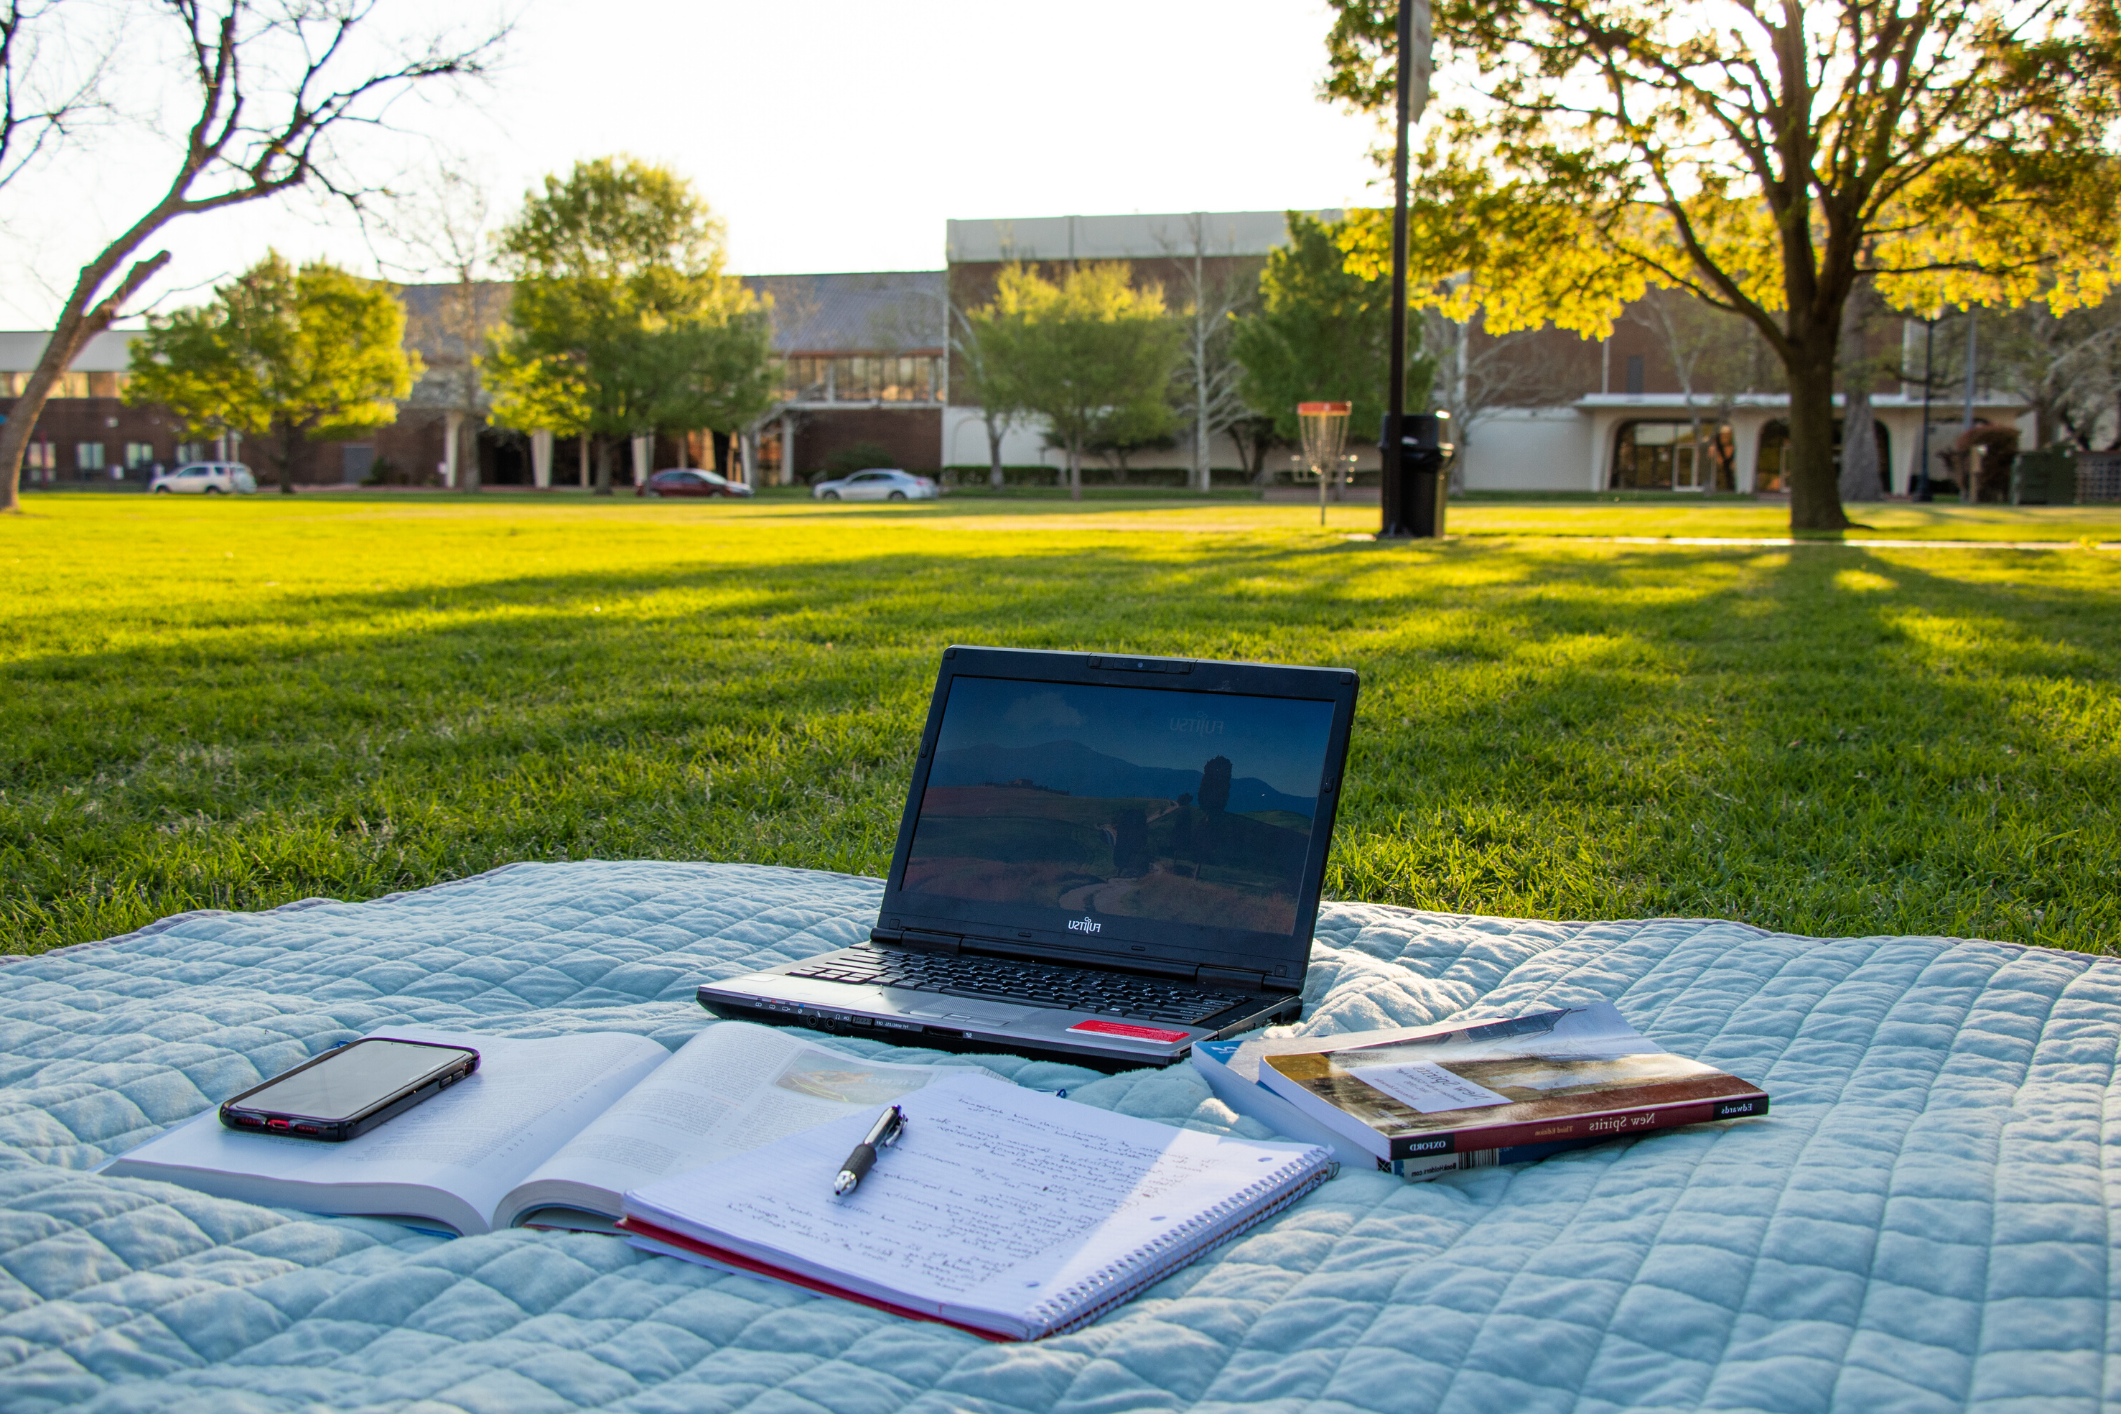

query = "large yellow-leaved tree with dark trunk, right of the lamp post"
[1326, 0, 2121, 530]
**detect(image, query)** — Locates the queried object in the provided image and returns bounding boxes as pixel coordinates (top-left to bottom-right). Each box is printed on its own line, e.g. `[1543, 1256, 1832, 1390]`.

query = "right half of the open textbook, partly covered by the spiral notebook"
[494, 1022, 991, 1227]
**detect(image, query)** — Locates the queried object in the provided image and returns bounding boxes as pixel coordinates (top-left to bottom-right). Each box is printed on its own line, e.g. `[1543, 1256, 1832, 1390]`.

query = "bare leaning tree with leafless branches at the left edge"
[0, 0, 501, 511]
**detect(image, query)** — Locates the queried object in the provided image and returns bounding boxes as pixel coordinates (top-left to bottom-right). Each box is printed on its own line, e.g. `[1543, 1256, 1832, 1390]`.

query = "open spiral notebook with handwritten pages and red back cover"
[619, 1075, 1334, 1340]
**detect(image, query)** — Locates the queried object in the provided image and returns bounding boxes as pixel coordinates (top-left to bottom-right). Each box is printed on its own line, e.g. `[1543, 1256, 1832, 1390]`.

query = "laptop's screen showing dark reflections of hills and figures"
[901, 676, 1334, 935]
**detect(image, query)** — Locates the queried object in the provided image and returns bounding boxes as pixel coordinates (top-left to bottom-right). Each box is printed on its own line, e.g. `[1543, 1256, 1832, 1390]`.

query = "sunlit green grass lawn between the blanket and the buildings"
[0, 494, 2121, 952]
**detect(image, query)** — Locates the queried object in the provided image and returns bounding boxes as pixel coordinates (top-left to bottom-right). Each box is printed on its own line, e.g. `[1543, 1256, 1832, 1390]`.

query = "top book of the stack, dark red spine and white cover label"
[1258, 1003, 1767, 1177]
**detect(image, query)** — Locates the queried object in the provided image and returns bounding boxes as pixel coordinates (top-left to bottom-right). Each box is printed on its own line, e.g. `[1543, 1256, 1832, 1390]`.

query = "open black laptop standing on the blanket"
[700, 647, 1357, 1068]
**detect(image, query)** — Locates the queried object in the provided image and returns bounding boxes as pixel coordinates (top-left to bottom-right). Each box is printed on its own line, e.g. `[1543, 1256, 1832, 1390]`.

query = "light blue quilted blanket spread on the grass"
[0, 863, 2121, 1414]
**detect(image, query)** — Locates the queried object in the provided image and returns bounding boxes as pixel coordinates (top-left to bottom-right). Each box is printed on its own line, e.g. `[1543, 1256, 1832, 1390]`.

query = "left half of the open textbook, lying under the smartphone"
[104, 1026, 670, 1232]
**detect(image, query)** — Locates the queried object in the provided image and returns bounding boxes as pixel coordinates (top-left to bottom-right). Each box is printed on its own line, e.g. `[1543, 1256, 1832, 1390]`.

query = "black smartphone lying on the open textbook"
[221, 1037, 479, 1145]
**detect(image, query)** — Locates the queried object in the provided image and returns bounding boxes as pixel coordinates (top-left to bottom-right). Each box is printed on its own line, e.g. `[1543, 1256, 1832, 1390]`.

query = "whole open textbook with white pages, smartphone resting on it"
[104, 1022, 984, 1232]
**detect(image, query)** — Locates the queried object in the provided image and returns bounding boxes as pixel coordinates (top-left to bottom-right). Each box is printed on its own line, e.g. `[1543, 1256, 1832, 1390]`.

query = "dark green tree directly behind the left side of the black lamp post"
[1234, 212, 1432, 443]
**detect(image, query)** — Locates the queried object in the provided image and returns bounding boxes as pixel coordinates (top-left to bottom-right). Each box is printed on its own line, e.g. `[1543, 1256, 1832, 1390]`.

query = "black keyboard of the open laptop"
[787, 948, 1251, 1026]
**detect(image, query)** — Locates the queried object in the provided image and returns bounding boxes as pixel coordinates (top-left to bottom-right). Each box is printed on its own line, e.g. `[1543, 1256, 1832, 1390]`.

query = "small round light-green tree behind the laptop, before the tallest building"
[971, 261, 1184, 500]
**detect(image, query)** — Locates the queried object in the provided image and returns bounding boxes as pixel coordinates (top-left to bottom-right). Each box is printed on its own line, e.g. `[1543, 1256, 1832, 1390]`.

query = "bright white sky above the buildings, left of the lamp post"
[0, 0, 1381, 329]
